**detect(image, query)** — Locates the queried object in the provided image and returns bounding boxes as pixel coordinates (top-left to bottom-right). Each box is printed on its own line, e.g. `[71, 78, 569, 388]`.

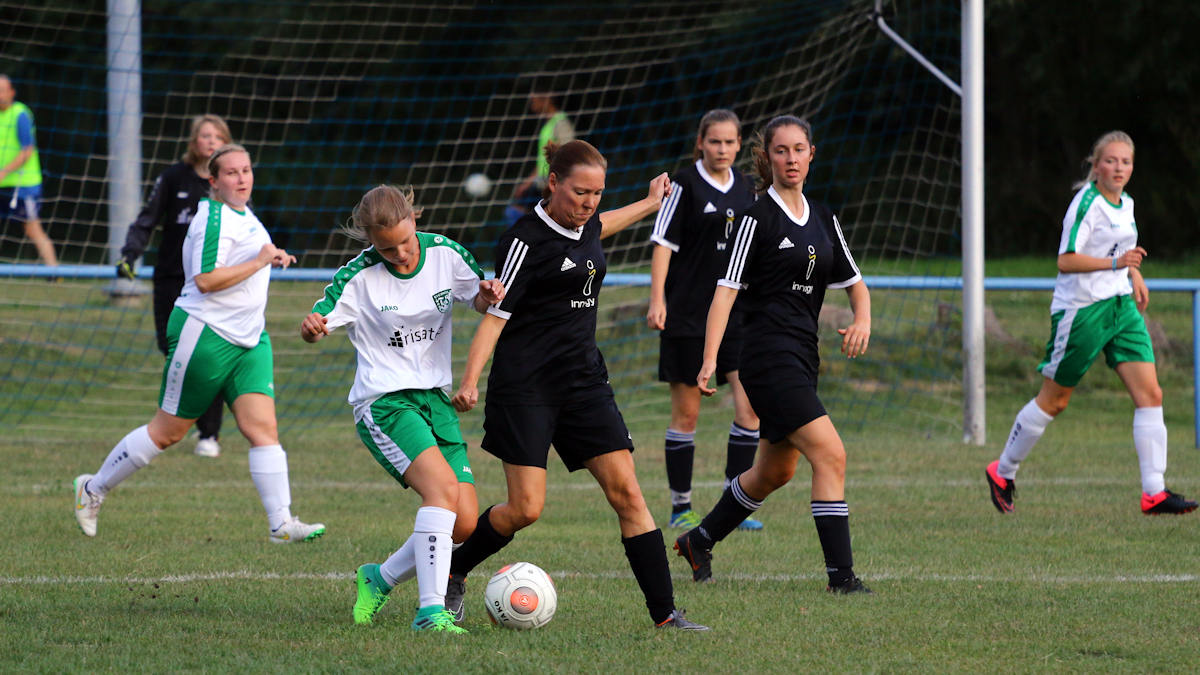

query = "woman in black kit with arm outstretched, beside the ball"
[446, 141, 707, 631]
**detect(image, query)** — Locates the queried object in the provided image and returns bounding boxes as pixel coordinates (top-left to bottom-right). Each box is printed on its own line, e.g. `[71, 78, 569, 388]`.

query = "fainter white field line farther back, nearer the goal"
[9, 471, 1198, 495]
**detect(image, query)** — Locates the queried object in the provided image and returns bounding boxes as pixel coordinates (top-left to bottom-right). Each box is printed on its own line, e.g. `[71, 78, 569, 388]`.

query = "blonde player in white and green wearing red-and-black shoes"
[985, 131, 1196, 515]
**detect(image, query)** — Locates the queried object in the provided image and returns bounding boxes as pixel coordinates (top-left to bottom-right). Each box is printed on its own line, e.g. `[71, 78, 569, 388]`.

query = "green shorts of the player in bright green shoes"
[355, 389, 475, 488]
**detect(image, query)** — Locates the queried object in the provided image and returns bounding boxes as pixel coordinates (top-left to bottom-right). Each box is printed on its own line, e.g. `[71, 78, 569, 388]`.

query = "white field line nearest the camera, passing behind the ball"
[0, 569, 1200, 586]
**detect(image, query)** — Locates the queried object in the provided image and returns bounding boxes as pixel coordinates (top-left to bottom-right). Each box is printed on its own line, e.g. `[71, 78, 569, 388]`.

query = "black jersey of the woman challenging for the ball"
[487, 199, 608, 405]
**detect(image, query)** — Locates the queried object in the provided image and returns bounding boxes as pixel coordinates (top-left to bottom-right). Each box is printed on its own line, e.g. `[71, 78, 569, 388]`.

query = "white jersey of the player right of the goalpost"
[1050, 183, 1138, 312]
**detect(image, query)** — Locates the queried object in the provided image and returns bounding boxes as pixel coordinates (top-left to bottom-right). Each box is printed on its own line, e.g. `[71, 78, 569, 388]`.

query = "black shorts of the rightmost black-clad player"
[738, 363, 828, 443]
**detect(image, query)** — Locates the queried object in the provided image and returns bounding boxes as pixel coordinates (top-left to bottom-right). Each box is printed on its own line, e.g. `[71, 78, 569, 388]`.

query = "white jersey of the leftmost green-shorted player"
[175, 199, 271, 348]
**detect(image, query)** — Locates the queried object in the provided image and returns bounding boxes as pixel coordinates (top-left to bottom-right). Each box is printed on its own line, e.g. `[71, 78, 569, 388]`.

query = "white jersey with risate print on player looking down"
[312, 232, 484, 419]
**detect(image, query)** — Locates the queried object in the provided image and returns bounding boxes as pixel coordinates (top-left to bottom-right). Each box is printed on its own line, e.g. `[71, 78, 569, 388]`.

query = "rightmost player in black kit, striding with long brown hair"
[676, 115, 871, 593]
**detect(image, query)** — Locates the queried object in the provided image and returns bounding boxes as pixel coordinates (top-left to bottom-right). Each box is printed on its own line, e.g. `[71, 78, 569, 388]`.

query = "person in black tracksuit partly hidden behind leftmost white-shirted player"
[116, 115, 233, 458]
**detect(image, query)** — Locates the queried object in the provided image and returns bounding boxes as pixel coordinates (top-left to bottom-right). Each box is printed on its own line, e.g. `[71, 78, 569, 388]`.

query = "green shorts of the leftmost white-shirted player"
[158, 307, 275, 419]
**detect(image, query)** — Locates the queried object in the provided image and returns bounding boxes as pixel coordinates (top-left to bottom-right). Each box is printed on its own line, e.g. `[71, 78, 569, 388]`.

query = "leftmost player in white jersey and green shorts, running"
[74, 143, 325, 544]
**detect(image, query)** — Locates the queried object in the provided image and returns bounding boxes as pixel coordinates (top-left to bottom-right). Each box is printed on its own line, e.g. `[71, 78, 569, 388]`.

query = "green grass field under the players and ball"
[0, 258, 1200, 673]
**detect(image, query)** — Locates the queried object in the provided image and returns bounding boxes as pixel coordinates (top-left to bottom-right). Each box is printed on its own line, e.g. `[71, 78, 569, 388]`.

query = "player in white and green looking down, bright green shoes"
[300, 185, 504, 633]
